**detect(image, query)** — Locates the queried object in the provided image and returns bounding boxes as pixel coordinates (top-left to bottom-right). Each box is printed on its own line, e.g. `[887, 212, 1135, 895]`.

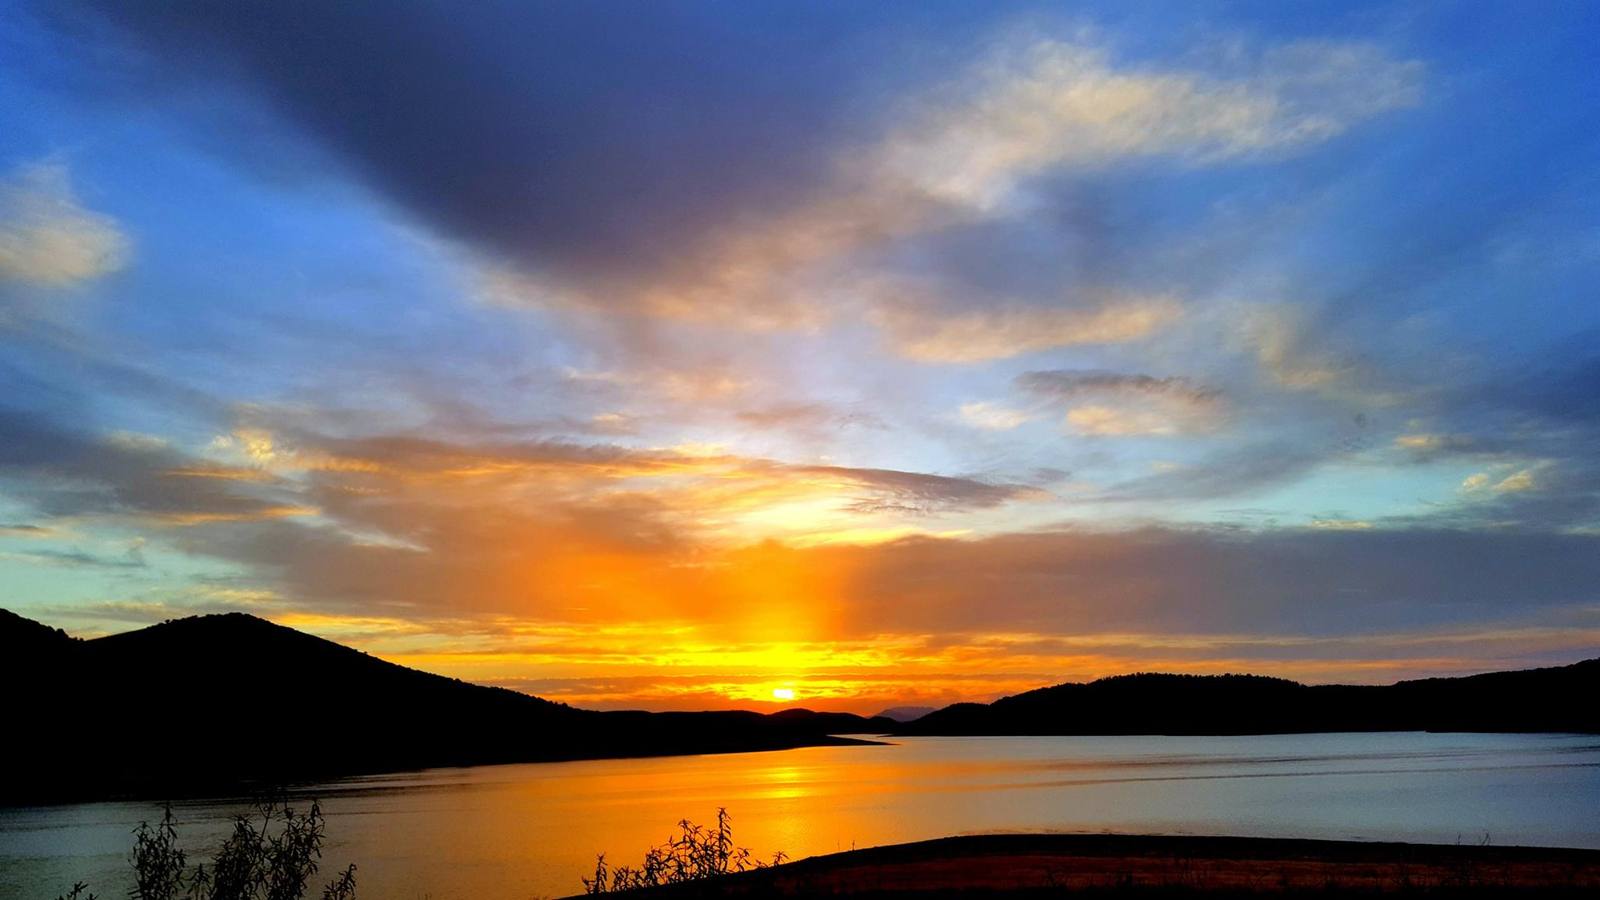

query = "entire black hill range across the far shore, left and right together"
[9, 610, 1600, 804]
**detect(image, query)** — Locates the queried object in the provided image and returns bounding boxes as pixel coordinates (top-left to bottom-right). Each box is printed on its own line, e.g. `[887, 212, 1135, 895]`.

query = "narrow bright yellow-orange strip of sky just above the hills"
[268, 598, 1600, 714]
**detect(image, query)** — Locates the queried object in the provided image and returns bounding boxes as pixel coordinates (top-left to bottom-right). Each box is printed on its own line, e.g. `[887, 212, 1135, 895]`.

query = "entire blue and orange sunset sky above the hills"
[0, 0, 1600, 713]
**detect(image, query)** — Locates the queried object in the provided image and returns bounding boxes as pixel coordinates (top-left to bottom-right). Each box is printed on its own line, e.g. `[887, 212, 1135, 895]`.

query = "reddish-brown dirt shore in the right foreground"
[569, 834, 1600, 900]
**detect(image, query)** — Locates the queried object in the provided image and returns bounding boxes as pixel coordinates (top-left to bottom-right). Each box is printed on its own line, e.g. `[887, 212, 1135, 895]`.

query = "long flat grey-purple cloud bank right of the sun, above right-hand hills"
[827, 528, 1600, 636]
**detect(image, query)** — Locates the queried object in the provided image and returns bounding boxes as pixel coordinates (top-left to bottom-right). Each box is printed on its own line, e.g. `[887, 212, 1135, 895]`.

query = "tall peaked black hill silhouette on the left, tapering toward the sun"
[0, 610, 894, 804]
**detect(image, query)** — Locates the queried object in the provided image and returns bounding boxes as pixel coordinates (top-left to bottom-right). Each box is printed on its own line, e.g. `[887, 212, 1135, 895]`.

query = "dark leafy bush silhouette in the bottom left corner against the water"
[58, 801, 355, 900]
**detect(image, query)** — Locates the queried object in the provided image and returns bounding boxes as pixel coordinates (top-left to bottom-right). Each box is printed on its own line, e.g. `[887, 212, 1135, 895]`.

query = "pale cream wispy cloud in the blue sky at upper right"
[872, 38, 1422, 210]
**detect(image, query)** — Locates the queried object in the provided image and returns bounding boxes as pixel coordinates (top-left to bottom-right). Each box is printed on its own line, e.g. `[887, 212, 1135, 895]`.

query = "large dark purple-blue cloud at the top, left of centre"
[46, 0, 976, 293]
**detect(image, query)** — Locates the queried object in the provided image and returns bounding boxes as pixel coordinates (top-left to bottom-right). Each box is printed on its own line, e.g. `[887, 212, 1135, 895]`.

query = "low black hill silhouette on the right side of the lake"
[893, 658, 1600, 735]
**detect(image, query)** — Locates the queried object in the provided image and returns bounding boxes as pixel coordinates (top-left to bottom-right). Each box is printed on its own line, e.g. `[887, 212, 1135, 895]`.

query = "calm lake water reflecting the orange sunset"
[0, 733, 1600, 900]
